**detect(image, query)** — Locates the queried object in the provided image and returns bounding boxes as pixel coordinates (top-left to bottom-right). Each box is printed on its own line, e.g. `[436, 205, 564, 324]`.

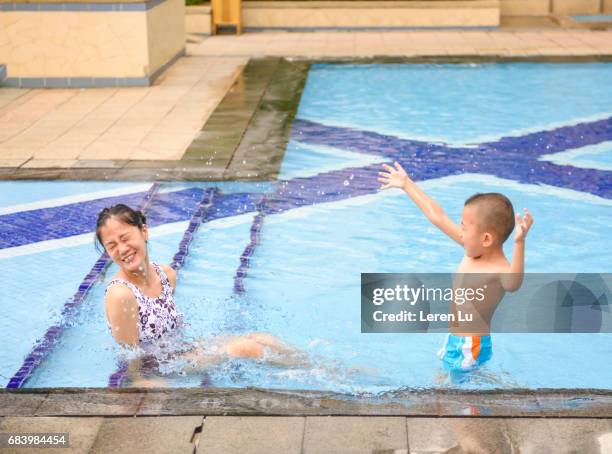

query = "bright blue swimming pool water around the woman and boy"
[0, 63, 612, 392]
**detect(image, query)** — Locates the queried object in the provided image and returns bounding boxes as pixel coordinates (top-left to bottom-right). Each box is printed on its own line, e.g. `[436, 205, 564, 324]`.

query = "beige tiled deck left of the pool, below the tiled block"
[0, 56, 247, 168]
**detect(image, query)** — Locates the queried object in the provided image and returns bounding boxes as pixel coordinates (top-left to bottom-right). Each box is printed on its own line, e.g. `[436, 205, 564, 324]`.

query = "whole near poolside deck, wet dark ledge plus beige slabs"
[0, 388, 612, 454]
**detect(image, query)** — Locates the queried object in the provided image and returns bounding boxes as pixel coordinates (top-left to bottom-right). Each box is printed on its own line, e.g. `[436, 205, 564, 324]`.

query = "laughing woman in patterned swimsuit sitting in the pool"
[96, 204, 300, 378]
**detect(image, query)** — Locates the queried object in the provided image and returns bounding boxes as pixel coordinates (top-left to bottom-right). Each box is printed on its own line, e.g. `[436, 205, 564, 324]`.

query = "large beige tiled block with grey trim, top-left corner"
[0, 0, 185, 78]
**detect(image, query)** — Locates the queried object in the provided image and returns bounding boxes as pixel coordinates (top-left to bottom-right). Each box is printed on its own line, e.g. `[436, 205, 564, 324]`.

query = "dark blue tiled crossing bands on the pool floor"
[0, 117, 612, 249]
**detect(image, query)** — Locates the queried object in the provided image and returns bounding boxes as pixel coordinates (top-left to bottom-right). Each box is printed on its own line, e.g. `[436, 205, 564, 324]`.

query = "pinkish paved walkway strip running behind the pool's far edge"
[188, 28, 612, 58]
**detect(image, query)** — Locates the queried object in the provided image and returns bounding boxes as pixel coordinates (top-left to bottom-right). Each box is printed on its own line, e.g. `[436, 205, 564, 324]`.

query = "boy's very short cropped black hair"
[465, 192, 514, 244]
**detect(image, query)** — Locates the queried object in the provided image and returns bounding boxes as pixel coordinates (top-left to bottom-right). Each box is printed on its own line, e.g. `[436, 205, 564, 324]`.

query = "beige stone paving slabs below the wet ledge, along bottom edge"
[0, 416, 612, 454]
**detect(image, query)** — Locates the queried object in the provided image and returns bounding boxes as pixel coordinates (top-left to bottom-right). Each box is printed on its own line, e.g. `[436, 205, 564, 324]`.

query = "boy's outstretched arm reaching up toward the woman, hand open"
[378, 162, 463, 245]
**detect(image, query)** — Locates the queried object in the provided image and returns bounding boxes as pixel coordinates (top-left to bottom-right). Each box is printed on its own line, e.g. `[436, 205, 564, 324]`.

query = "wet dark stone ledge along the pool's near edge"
[0, 387, 612, 418]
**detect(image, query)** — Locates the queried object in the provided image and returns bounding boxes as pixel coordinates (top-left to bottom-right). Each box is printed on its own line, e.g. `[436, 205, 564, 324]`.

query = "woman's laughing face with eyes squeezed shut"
[100, 216, 149, 273]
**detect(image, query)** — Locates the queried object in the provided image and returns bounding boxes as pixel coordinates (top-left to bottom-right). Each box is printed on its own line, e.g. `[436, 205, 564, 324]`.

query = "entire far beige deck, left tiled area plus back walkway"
[0, 26, 612, 179]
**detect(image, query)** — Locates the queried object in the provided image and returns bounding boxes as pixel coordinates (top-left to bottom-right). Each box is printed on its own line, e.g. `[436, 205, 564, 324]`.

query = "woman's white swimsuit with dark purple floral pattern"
[106, 263, 182, 343]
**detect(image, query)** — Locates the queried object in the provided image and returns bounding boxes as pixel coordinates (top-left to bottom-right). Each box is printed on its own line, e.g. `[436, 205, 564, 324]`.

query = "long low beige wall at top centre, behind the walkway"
[242, 0, 500, 30]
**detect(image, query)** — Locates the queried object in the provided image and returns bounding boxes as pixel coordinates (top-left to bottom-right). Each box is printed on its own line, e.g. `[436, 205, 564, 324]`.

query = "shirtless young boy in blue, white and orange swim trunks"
[378, 162, 533, 371]
